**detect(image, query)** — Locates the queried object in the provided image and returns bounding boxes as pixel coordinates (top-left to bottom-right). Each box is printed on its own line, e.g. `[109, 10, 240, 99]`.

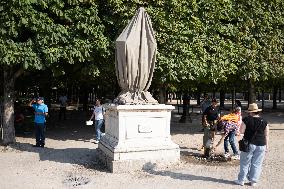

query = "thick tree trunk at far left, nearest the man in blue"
[1, 66, 16, 145]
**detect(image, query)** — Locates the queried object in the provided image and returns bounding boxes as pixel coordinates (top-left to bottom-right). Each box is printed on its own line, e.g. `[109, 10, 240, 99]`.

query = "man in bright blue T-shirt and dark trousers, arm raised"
[29, 97, 48, 148]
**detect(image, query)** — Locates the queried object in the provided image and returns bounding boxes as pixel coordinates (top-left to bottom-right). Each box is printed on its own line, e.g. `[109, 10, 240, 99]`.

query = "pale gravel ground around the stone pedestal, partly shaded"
[0, 108, 284, 189]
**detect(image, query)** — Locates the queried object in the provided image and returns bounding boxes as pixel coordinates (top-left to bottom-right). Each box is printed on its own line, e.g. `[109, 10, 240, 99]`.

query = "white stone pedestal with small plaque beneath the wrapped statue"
[98, 104, 180, 172]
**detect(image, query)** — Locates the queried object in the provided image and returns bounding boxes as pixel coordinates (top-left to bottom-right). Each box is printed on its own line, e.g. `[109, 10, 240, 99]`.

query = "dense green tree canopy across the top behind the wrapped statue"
[0, 0, 284, 145]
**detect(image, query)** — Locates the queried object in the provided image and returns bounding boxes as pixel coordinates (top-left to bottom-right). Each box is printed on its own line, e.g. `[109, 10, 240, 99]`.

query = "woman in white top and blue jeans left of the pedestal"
[90, 99, 105, 144]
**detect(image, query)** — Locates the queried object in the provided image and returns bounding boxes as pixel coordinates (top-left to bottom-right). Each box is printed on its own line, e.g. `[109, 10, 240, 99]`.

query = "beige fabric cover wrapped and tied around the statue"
[115, 8, 158, 104]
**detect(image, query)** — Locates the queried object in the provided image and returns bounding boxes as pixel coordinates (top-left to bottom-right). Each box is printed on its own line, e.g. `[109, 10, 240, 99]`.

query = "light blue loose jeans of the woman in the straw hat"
[238, 144, 266, 183]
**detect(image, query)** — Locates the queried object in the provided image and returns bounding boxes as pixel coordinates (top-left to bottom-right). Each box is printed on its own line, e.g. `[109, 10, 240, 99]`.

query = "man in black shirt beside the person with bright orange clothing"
[202, 99, 220, 157]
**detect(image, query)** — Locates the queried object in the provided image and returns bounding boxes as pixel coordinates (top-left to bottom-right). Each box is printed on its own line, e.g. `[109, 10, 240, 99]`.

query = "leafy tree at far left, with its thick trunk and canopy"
[0, 0, 109, 145]
